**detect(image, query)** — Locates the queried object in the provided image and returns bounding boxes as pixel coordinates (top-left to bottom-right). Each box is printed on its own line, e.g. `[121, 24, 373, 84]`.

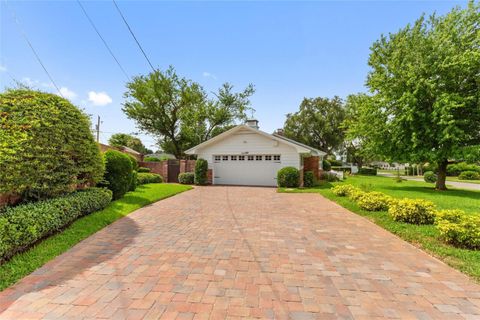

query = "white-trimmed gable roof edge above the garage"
[185, 124, 325, 155]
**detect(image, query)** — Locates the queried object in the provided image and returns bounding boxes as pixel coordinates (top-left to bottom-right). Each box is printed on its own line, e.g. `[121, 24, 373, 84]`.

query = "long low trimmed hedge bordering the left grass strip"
[0, 188, 112, 263]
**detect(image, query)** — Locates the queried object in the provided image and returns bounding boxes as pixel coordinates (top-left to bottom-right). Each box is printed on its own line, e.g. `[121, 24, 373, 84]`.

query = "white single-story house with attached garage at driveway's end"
[186, 120, 326, 186]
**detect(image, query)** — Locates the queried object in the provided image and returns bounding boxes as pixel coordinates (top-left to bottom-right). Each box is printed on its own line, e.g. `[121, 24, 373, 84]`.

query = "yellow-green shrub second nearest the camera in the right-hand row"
[388, 199, 435, 224]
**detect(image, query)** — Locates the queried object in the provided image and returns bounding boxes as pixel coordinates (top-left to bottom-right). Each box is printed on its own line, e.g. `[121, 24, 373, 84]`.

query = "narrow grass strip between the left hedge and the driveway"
[0, 183, 192, 290]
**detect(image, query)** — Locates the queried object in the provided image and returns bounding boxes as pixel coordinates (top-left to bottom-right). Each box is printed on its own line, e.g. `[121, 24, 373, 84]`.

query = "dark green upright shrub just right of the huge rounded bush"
[102, 150, 133, 199]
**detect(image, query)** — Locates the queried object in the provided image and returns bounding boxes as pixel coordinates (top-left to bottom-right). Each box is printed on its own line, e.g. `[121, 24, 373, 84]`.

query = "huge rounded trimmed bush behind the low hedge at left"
[0, 89, 104, 199]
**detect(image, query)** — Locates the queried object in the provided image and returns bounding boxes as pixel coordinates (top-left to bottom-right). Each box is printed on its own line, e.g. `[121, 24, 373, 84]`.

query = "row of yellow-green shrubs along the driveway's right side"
[332, 184, 480, 249]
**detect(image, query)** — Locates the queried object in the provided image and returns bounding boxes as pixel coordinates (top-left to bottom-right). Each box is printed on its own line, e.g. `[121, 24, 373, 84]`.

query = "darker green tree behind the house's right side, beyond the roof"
[284, 96, 345, 154]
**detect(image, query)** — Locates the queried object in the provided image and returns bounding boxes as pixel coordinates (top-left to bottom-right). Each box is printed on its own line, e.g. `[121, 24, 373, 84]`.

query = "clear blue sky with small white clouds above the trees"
[0, 0, 466, 150]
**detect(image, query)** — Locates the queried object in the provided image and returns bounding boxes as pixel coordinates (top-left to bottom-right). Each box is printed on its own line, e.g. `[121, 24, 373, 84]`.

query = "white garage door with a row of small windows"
[213, 154, 281, 186]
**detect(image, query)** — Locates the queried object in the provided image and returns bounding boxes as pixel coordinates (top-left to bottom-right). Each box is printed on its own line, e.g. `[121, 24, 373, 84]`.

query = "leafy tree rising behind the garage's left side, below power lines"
[123, 67, 255, 158]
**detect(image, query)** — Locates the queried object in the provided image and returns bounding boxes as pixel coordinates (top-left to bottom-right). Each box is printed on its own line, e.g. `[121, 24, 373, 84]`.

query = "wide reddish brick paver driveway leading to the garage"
[0, 187, 480, 319]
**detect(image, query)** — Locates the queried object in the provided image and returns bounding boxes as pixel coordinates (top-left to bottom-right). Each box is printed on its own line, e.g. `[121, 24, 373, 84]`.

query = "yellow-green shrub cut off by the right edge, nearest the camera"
[435, 210, 480, 249]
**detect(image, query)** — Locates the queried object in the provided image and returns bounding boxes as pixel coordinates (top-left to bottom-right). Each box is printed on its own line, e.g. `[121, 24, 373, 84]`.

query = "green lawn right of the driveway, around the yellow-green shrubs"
[280, 176, 480, 281]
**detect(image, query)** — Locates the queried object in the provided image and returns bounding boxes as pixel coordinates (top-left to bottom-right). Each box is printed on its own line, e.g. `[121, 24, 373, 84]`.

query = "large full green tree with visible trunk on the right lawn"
[349, 2, 480, 190]
